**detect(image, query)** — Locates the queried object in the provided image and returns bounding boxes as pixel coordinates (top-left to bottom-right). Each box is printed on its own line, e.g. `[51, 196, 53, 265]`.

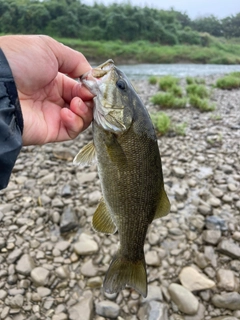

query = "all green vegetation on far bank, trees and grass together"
[0, 0, 240, 64]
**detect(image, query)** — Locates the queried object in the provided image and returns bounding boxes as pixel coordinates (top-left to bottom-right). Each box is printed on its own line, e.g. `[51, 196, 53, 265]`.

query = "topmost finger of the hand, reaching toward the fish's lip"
[42, 36, 91, 78]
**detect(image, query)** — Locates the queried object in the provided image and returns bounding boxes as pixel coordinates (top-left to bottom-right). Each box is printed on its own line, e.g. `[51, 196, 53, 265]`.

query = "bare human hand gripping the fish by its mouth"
[0, 35, 93, 145]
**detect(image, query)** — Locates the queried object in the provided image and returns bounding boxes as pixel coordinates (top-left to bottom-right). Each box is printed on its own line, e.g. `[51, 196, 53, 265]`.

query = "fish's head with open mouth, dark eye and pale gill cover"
[81, 60, 134, 134]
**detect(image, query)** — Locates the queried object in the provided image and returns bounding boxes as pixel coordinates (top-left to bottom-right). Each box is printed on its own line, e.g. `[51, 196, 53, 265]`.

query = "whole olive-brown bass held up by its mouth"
[74, 59, 170, 297]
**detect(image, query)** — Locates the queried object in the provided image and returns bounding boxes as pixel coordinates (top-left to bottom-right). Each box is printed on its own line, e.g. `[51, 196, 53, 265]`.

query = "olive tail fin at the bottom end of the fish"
[103, 253, 147, 297]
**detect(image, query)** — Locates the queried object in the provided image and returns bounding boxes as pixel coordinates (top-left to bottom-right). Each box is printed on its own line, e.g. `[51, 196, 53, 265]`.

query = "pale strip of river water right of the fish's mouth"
[117, 63, 240, 79]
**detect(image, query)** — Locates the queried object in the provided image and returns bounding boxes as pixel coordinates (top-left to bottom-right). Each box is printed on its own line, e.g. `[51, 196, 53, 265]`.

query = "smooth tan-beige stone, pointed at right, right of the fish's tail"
[179, 267, 215, 291]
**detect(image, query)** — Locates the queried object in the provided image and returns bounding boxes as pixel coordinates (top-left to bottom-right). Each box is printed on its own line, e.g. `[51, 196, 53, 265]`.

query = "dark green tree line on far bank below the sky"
[0, 0, 240, 46]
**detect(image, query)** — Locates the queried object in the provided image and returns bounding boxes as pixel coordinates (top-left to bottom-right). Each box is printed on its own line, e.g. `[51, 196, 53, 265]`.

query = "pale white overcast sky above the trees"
[81, 0, 240, 19]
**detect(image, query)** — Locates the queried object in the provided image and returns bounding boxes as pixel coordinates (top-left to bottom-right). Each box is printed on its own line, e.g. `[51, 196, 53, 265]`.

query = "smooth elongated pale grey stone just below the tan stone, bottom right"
[168, 283, 199, 315]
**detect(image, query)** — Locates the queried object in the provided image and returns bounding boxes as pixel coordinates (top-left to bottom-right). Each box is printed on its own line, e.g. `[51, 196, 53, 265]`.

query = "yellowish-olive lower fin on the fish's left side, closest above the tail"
[92, 199, 117, 234]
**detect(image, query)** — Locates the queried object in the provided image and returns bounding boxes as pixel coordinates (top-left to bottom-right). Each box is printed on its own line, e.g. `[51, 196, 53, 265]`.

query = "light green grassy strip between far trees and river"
[57, 36, 240, 64]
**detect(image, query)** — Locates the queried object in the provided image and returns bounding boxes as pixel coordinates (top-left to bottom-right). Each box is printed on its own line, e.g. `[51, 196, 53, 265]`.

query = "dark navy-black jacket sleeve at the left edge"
[0, 49, 23, 189]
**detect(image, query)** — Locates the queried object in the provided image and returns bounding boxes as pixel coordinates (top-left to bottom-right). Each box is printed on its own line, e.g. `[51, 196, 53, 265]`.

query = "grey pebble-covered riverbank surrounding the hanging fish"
[0, 76, 240, 320]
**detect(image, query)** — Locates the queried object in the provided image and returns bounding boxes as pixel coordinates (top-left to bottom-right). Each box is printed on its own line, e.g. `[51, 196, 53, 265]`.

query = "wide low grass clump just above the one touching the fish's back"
[151, 92, 187, 108]
